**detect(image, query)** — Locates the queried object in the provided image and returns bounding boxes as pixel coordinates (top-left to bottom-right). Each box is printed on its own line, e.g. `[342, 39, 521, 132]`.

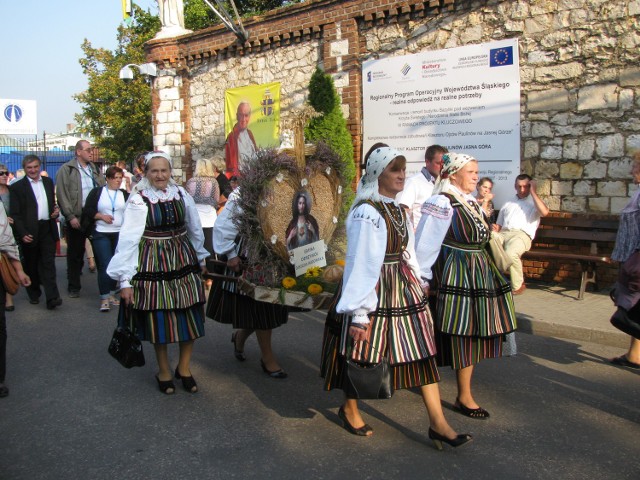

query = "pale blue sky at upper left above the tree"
[0, 0, 158, 137]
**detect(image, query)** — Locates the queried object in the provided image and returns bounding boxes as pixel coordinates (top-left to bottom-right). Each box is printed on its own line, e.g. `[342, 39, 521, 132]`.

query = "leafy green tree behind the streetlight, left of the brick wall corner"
[74, 4, 160, 160]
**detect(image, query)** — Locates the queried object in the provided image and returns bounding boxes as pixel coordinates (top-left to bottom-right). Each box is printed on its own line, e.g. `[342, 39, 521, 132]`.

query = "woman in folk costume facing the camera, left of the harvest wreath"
[107, 152, 209, 394]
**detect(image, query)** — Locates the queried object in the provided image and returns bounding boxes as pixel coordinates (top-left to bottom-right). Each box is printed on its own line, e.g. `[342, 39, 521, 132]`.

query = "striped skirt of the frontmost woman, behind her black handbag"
[320, 261, 440, 390]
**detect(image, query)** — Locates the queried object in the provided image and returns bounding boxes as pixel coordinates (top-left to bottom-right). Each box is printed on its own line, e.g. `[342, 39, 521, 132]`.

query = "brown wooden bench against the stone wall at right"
[523, 217, 619, 300]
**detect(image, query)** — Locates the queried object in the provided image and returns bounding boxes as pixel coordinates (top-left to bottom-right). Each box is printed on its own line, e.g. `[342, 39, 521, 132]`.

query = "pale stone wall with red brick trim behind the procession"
[147, 0, 640, 284]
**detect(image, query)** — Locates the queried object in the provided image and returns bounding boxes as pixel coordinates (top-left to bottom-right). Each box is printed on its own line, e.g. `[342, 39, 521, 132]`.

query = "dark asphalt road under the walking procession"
[0, 259, 640, 480]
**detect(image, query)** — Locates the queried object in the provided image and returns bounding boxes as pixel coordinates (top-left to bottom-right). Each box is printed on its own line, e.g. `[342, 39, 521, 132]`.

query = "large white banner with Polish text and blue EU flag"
[362, 38, 521, 207]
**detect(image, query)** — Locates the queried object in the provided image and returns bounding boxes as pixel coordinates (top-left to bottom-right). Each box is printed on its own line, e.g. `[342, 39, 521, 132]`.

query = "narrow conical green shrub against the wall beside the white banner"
[305, 68, 356, 213]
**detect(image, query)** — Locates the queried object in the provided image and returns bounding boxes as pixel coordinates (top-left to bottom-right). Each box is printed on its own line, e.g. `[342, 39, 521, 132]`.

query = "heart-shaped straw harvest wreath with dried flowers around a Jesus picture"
[210, 143, 345, 309]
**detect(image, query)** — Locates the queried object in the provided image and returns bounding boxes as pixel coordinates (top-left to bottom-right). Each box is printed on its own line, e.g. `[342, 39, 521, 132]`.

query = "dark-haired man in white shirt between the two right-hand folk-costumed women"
[396, 145, 448, 232]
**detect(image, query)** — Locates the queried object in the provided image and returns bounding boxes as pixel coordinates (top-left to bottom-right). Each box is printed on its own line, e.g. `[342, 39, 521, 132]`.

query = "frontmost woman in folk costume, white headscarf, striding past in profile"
[321, 144, 471, 448]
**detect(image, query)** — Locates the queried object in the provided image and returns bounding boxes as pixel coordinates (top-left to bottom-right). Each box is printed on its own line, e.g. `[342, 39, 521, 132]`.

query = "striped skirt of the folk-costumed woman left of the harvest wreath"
[131, 230, 205, 344]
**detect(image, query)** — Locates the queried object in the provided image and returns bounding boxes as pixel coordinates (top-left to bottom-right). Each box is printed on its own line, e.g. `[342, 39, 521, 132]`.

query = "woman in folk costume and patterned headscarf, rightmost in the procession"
[416, 152, 516, 419]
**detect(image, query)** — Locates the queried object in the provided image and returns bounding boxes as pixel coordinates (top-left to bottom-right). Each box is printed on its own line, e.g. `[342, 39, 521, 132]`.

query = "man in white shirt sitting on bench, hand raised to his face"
[492, 173, 549, 295]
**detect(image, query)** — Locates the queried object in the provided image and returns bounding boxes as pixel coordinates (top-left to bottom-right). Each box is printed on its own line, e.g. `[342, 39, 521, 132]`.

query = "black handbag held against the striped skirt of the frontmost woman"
[342, 347, 393, 400]
